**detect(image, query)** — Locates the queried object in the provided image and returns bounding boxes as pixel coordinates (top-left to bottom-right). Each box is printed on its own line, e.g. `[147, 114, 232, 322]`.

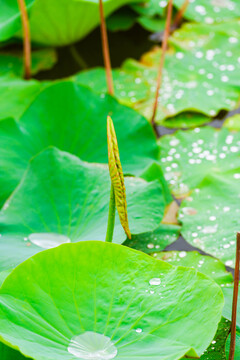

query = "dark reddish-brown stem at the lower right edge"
[228, 233, 240, 360]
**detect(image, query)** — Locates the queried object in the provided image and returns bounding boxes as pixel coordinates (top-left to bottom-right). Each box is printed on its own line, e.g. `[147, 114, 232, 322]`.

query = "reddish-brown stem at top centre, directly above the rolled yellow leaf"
[99, 0, 114, 95]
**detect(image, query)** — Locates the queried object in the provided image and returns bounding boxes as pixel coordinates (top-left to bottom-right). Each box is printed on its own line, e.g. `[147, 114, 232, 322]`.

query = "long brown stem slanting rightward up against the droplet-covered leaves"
[151, 0, 173, 131]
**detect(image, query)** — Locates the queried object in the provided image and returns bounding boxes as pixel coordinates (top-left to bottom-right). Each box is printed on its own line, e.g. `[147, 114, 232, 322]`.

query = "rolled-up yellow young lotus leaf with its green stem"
[106, 116, 131, 242]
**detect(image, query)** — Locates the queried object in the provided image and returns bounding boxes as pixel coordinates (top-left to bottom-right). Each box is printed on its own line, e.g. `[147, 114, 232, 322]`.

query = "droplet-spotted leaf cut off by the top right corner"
[174, 0, 240, 24]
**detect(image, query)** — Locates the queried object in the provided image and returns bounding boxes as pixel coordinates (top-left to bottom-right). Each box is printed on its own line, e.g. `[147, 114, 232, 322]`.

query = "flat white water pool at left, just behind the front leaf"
[28, 233, 71, 249]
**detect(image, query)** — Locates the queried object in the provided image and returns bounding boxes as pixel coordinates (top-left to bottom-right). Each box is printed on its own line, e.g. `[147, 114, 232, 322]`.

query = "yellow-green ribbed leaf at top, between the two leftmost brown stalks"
[13, 0, 138, 46]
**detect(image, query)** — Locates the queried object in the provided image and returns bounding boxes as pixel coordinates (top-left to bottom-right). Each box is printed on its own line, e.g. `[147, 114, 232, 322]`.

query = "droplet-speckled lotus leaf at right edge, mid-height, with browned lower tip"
[159, 127, 240, 198]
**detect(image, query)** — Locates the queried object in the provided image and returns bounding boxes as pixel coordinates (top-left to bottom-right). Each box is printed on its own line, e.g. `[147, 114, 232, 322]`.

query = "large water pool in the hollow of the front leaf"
[68, 331, 117, 360]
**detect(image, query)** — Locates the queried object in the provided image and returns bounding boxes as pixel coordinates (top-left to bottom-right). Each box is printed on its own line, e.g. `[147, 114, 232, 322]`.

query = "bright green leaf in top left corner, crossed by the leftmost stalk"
[0, 0, 35, 41]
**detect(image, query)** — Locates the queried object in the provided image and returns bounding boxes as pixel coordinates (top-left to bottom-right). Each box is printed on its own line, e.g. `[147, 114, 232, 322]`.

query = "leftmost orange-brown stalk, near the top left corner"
[18, 0, 32, 80]
